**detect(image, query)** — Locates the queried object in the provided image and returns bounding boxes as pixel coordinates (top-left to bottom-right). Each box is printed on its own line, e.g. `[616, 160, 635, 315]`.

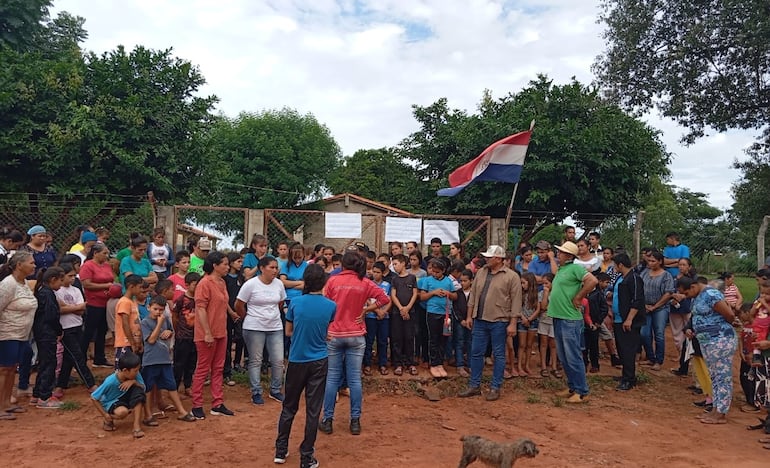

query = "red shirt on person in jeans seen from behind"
[325, 270, 390, 338]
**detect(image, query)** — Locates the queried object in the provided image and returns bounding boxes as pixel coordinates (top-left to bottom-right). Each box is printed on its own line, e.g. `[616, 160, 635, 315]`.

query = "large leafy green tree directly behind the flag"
[401, 76, 669, 240]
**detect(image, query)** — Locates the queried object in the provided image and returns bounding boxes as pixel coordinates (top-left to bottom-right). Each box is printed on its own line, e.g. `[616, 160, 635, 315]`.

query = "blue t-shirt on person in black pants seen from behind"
[286, 294, 337, 362]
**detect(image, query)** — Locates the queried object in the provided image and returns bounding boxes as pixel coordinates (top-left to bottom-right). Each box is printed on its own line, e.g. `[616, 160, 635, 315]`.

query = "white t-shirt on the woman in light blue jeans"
[238, 276, 286, 331]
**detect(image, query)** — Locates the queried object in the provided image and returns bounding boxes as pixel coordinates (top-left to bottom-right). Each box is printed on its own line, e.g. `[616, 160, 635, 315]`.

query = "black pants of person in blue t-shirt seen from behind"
[275, 358, 329, 458]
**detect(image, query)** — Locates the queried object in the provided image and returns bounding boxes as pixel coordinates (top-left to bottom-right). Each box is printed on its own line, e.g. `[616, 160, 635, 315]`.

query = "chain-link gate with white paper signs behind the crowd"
[264, 209, 491, 255]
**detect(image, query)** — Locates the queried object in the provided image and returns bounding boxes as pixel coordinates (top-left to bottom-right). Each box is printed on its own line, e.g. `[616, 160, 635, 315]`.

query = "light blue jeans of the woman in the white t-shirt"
[243, 330, 283, 395]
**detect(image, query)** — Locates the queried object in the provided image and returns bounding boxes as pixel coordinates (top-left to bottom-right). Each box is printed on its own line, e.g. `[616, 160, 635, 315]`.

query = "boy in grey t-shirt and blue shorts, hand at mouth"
[141, 294, 195, 426]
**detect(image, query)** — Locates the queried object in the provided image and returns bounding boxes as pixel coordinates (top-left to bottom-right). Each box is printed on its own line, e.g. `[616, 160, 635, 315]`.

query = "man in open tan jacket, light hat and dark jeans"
[457, 245, 520, 401]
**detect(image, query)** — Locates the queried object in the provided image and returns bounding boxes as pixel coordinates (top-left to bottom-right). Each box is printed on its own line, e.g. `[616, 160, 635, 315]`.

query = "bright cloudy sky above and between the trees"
[52, 0, 753, 208]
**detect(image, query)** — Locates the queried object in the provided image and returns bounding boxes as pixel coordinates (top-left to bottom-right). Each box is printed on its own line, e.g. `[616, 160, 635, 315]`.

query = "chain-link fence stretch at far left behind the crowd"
[0, 193, 154, 254]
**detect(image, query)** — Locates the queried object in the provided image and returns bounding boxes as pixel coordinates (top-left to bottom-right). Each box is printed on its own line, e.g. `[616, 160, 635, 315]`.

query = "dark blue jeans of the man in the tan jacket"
[468, 319, 508, 390]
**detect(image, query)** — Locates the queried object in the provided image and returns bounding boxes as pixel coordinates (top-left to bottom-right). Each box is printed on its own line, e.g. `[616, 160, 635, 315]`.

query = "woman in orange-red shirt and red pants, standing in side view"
[191, 251, 234, 419]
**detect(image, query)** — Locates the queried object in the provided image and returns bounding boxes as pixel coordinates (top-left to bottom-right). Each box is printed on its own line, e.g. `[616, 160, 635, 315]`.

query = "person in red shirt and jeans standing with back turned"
[319, 251, 390, 435]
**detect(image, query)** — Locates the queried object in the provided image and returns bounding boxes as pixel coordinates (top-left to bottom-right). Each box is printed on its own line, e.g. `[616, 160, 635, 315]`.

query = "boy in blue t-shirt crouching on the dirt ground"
[91, 351, 146, 439]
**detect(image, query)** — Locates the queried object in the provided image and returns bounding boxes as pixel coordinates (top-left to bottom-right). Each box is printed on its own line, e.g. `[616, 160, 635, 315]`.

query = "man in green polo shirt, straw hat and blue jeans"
[548, 241, 598, 403]
